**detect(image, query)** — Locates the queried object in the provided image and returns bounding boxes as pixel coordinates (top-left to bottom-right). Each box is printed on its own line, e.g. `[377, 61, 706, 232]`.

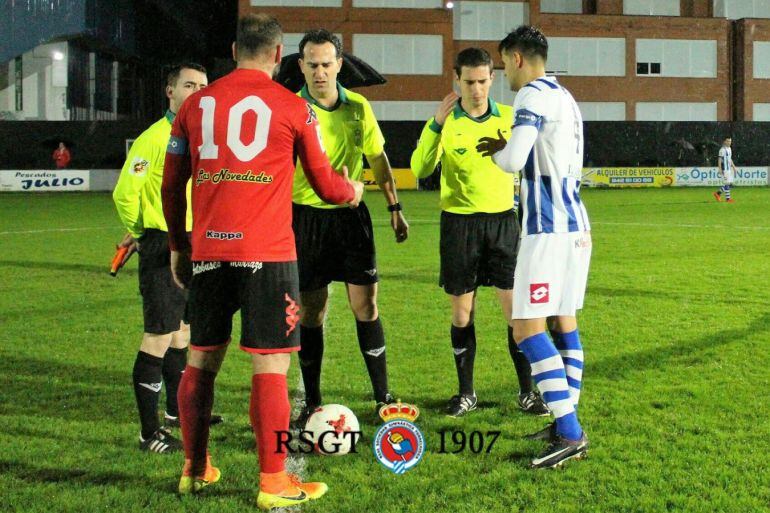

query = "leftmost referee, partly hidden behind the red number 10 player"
[112, 63, 222, 453]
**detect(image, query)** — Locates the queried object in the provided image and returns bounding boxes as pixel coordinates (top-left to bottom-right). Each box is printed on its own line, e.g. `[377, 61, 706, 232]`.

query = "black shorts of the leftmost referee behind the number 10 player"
[138, 228, 187, 335]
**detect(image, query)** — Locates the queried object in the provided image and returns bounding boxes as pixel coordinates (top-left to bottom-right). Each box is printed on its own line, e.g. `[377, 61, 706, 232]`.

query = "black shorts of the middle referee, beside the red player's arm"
[293, 201, 379, 292]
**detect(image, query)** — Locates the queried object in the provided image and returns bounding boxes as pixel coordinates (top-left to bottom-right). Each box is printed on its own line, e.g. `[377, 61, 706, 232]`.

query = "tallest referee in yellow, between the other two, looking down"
[292, 30, 409, 427]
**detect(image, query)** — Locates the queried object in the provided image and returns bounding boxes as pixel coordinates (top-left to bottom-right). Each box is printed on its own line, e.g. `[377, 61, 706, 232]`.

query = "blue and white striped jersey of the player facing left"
[498, 77, 591, 236]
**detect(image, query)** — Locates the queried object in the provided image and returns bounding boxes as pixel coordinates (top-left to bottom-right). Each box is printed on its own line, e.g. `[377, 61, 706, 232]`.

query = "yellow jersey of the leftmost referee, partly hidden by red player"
[112, 110, 192, 238]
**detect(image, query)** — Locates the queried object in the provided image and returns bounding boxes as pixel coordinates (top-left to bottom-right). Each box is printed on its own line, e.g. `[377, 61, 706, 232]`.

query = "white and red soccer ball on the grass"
[305, 404, 361, 456]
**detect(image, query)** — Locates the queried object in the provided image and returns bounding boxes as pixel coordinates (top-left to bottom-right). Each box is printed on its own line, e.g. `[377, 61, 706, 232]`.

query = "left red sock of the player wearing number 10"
[177, 365, 217, 475]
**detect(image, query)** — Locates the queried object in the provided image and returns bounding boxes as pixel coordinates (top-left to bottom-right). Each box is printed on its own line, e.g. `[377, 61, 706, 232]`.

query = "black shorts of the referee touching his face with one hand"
[439, 210, 521, 296]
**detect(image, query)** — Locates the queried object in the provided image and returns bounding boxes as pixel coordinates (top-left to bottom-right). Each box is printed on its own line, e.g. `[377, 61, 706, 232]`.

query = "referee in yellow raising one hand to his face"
[411, 48, 549, 417]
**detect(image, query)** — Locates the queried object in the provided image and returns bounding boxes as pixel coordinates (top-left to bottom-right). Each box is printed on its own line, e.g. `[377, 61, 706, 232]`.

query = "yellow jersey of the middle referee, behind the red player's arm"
[292, 84, 385, 208]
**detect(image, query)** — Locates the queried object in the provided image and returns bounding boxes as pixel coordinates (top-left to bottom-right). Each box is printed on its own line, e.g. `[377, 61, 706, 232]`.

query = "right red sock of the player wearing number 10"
[249, 374, 291, 474]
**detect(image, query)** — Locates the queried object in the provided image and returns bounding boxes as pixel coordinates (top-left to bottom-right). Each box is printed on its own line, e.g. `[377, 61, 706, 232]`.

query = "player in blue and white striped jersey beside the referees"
[478, 26, 591, 468]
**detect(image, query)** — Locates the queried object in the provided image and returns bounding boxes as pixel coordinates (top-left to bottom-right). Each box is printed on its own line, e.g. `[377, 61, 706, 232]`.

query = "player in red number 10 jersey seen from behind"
[162, 15, 363, 509]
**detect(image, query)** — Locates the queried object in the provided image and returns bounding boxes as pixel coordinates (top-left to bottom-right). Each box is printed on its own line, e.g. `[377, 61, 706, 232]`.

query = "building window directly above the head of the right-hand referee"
[453, 0, 529, 41]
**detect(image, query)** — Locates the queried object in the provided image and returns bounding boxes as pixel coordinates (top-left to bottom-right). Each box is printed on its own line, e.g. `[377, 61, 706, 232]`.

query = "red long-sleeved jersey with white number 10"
[162, 68, 354, 262]
